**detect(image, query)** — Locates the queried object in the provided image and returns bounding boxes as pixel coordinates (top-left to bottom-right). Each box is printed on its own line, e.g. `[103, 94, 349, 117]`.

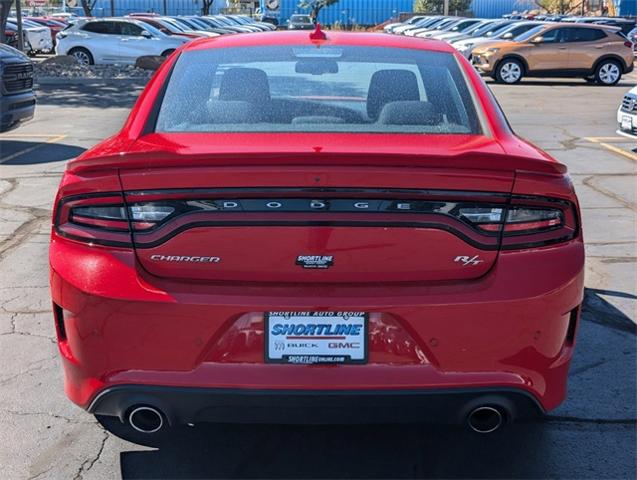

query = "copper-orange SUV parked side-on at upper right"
[472, 23, 635, 85]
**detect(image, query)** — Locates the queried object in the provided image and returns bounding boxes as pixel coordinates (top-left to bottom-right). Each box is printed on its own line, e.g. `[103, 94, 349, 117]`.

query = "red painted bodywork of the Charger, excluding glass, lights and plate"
[50, 32, 584, 420]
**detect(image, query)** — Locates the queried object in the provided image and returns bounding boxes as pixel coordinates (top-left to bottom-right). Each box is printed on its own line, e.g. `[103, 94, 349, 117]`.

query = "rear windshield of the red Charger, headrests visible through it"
[155, 46, 481, 134]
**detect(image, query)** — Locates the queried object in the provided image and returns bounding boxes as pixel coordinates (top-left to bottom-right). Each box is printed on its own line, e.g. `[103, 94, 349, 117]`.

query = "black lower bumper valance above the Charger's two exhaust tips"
[88, 385, 544, 425]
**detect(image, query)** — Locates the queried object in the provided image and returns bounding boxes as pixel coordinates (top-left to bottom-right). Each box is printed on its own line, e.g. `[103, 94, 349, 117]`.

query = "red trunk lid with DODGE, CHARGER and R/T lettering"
[114, 135, 514, 283]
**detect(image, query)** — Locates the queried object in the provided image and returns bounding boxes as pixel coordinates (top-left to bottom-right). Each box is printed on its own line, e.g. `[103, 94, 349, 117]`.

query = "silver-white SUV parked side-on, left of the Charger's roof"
[56, 18, 190, 65]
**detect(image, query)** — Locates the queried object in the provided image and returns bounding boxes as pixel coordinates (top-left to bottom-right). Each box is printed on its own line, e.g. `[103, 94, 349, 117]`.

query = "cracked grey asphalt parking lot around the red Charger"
[0, 74, 637, 479]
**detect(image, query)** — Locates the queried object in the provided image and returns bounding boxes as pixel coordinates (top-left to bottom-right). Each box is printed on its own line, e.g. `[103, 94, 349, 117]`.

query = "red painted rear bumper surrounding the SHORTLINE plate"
[50, 235, 584, 411]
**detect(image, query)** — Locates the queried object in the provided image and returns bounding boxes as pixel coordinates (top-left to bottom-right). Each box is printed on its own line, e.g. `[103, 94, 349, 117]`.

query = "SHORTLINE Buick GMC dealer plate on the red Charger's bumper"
[264, 312, 369, 365]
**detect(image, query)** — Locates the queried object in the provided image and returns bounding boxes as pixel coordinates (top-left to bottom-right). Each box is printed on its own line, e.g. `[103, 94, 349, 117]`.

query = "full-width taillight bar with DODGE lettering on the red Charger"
[55, 192, 579, 250]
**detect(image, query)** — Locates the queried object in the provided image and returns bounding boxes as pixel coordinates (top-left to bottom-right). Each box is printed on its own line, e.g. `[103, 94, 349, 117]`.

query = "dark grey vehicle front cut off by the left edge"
[0, 44, 35, 132]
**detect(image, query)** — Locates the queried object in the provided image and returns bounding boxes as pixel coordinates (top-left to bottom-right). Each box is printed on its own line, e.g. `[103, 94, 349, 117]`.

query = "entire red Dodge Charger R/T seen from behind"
[50, 29, 584, 445]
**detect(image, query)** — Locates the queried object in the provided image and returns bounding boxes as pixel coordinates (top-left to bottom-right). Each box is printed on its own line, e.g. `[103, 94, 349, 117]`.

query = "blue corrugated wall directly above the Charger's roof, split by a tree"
[261, 0, 414, 26]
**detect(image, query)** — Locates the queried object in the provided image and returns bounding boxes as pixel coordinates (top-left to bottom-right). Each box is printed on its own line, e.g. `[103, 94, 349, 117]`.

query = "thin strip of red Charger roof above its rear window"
[183, 30, 456, 53]
